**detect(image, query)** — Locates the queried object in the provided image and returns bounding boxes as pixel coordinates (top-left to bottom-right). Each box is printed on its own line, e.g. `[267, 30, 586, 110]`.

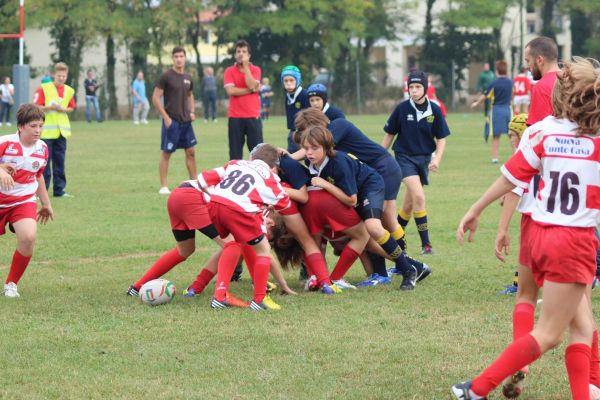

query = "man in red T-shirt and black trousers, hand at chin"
[223, 40, 263, 160]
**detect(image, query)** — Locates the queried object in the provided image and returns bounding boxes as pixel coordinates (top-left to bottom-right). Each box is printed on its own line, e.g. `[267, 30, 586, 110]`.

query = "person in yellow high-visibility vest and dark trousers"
[33, 62, 75, 197]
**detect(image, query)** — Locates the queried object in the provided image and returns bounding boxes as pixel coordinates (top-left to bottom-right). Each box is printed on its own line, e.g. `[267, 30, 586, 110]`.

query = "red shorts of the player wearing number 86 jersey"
[208, 202, 264, 244]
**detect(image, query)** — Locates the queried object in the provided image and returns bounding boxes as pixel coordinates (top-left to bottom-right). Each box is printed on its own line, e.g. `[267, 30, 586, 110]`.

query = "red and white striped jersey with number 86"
[198, 160, 290, 213]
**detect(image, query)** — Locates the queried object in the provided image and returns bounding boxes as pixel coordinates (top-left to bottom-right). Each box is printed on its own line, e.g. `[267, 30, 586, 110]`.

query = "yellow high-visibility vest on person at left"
[41, 82, 75, 139]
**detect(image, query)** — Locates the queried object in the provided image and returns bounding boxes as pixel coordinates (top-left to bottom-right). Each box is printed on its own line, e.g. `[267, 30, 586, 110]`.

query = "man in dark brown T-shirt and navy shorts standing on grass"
[152, 46, 198, 194]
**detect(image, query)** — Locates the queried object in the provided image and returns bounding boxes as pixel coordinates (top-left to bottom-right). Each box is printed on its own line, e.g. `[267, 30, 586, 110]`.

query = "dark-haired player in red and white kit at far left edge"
[0, 104, 54, 298]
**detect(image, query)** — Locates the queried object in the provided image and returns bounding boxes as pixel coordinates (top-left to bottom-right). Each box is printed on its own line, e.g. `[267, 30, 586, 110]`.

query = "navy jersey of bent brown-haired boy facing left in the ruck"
[309, 151, 383, 196]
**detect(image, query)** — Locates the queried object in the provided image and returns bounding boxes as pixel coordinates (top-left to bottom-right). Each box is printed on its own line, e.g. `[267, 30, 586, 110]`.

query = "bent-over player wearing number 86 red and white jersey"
[198, 143, 290, 311]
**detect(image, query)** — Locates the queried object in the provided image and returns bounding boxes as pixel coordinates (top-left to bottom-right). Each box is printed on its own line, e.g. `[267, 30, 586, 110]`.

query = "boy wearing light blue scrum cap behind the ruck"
[281, 65, 310, 153]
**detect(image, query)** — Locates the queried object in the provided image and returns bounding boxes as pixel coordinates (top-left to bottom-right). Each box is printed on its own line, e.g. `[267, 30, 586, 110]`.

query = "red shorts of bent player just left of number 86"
[167, 187, 212, 231]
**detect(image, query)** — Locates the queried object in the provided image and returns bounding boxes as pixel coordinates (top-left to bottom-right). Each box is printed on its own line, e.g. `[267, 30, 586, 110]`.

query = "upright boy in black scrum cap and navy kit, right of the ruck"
[382, 71, 450, 254]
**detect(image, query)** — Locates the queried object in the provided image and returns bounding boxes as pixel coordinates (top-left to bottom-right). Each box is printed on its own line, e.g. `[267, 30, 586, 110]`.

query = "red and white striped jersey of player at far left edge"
[0, 133, 48, 208]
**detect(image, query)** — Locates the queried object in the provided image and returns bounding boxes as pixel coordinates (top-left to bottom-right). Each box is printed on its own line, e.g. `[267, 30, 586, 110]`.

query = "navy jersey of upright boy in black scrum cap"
[383, 99, 450, 155]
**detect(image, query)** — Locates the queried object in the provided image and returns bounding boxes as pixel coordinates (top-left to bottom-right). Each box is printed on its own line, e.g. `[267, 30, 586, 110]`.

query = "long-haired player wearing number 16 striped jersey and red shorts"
[451, 58, 600, 400]
